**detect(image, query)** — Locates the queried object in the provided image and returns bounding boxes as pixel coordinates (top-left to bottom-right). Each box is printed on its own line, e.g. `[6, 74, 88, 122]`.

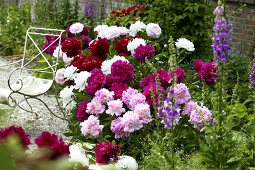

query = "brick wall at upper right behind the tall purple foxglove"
[227, 0, 255, 57]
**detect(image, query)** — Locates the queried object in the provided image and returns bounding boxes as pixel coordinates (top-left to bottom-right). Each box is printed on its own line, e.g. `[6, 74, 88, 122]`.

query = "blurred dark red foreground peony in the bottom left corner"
[0, 126, 31, 148]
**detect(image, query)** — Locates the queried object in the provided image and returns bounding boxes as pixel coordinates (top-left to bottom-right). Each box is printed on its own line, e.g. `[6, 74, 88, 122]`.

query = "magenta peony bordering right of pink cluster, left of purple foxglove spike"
[143, 82, 165, 106]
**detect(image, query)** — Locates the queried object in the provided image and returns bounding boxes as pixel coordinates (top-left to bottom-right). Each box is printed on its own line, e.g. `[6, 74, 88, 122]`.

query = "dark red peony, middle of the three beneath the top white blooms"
[89, 37, 110, 60]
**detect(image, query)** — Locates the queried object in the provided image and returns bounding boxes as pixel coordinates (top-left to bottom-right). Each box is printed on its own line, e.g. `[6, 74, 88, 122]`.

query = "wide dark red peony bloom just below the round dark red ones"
[70, 54, 102, 72]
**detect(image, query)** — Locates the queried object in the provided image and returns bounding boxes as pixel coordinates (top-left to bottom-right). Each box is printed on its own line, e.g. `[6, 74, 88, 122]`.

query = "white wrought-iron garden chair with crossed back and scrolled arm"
[3, 27, 68, 121]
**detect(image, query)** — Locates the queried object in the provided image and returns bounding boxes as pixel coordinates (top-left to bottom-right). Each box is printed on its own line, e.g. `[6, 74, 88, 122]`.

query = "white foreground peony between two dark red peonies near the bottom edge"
[69, 145, 89, 166]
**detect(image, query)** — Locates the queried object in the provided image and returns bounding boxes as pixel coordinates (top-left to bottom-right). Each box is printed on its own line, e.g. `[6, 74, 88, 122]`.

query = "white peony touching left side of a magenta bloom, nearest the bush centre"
[74, 71, 91, 91]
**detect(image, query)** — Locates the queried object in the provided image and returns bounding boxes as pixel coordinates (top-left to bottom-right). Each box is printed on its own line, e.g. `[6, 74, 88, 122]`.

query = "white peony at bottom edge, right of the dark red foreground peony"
[115, 156, 138, 170]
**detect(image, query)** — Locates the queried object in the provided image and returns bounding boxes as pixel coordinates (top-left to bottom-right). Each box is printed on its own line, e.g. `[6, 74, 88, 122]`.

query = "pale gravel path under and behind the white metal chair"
[0, 57, 67, 143]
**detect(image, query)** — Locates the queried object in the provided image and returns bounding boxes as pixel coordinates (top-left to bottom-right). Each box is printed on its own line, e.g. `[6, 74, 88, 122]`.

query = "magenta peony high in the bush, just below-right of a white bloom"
[133, 45, 155, 63]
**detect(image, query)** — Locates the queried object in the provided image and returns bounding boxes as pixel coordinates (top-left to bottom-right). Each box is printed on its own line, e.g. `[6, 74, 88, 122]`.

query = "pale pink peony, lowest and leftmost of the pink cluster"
[80, 115, 104, 137]
